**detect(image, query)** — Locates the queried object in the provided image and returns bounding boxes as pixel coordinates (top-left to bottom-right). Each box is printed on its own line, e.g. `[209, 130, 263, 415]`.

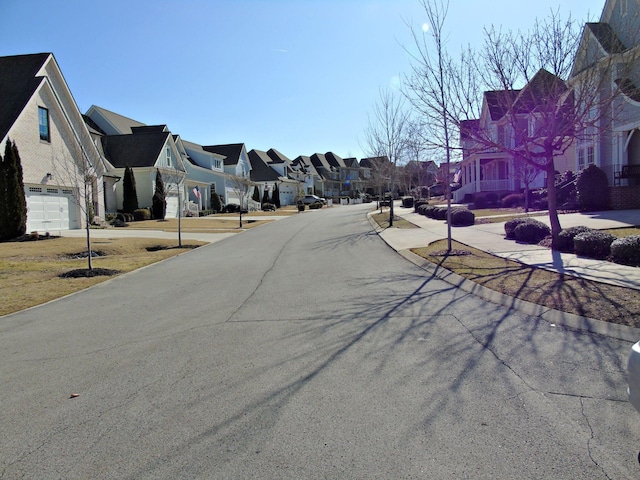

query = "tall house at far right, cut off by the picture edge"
[570, 0, 640, 209]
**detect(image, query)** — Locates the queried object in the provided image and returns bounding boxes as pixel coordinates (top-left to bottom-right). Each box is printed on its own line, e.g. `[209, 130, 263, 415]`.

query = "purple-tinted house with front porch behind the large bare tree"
[453, 70, 575, 202]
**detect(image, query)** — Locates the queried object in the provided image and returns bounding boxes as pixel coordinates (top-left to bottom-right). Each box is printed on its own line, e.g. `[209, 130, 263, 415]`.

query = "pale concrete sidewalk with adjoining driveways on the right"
[380, 205, 640, 290]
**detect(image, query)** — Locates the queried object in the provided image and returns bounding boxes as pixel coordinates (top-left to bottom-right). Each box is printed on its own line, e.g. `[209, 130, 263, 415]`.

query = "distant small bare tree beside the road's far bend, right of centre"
[365, 89, 409, 226]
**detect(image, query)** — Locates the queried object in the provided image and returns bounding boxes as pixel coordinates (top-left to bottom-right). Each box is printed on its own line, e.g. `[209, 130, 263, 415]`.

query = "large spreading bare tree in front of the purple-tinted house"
[407, 0, 624, 248]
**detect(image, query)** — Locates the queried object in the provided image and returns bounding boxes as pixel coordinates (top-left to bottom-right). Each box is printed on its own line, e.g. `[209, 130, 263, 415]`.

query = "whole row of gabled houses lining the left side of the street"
[0, 53, 388, 232]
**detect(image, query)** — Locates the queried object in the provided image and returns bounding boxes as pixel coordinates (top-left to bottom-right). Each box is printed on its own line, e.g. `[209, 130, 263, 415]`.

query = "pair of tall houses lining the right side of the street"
[453, 0, 640, 208]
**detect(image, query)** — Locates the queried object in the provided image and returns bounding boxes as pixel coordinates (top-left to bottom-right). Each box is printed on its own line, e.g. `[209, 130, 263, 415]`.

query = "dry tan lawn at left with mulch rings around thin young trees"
[0, 238, 205, 315]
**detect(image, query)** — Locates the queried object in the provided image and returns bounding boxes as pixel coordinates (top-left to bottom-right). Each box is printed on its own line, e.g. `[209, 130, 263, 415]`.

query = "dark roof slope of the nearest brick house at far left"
[0, 53, 51, 142]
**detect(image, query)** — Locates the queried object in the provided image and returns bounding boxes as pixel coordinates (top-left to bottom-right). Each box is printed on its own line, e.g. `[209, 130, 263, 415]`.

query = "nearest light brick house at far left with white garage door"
[0, 53, 111, 232]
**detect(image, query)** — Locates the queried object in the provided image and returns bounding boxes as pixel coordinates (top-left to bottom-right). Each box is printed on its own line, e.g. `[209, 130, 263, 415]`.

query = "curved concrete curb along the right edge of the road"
[367, 214, 640, 343]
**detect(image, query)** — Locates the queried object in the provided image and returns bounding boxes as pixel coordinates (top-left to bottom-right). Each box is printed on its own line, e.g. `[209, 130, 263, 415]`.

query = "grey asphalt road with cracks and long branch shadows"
[0, 205, 640, 479]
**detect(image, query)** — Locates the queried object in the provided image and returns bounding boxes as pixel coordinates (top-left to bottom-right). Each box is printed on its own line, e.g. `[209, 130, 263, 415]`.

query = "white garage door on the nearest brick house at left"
[26, 187, 80, 232]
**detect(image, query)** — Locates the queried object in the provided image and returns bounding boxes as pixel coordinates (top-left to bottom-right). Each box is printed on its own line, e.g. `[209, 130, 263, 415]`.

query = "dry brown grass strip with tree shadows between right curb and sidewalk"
[412, 240, 640, 327]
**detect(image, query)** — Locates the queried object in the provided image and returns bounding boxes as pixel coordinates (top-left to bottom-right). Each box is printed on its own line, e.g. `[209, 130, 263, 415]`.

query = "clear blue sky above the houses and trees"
[0, 0, 605, 159]
